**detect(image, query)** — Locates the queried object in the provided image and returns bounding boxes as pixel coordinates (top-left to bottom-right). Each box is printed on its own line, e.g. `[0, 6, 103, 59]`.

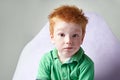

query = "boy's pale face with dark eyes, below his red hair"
[51, 18, 84, 58]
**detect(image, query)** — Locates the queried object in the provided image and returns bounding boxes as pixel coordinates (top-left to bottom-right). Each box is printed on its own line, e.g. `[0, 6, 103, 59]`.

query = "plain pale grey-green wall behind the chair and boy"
[0, 0, 120, 80]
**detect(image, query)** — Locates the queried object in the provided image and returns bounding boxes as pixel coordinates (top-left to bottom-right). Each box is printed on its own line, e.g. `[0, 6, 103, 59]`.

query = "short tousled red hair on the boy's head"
[48, 5, 88, 34]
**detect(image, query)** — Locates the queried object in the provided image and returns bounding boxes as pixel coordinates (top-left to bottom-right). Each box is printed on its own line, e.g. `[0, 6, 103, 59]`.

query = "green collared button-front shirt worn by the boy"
[36, 48, 94, 80]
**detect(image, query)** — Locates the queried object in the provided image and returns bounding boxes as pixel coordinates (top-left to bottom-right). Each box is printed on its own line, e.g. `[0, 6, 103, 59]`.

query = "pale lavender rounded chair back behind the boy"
[13, 13, 120, 80]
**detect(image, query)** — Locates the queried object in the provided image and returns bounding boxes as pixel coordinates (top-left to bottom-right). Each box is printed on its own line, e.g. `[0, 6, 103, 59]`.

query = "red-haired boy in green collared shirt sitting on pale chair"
[37, 5, 94, 80]
